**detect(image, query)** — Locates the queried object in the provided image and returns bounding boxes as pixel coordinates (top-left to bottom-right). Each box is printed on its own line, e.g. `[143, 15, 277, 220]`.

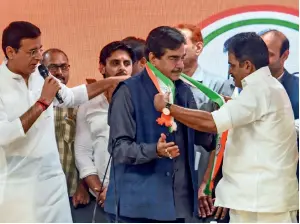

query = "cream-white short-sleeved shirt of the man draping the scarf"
[212, 67, 299, 213]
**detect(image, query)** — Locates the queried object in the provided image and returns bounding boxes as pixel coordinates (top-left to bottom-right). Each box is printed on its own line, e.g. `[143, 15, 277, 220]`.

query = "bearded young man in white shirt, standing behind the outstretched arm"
[75, 41, 134, 223]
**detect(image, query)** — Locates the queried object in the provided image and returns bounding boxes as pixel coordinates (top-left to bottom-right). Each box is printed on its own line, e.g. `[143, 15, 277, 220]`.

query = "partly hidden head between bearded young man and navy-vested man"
[122, 36, 147, 75]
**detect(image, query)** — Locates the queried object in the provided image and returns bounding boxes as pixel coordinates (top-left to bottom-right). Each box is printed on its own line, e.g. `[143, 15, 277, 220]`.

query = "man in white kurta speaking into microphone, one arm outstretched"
[0, 21, 129, 223]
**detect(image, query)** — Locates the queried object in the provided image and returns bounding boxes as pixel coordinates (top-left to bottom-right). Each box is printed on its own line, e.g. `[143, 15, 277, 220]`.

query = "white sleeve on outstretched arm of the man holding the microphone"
[53, 83, 89, 108]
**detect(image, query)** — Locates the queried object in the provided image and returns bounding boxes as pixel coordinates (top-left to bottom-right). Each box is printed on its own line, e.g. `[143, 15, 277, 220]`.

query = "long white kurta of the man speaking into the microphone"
[0, 63, 88, 222]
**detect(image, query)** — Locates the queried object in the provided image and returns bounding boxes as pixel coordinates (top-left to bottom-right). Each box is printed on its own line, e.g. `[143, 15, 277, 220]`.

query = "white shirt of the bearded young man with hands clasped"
[75, 94, 110, 192]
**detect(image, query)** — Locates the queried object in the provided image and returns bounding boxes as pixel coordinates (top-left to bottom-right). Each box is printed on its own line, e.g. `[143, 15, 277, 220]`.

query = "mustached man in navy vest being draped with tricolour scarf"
[105, 26, 212, 223]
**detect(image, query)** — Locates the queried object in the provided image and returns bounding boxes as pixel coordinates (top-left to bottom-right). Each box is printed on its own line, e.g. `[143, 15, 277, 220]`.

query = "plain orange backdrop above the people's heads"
[0, 0, 298, 86]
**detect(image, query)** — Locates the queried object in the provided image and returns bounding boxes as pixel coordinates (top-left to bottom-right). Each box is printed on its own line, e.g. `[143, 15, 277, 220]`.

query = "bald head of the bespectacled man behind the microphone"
[41, 48, 70, 85]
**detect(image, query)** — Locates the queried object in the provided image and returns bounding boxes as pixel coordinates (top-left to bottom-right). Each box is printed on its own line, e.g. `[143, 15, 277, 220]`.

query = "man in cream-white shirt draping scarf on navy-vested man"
[154, 32, 299, 223]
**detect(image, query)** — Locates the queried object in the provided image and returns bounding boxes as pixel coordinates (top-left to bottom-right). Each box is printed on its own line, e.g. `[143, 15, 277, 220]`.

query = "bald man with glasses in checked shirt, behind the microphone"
[42, 48, 90, 222]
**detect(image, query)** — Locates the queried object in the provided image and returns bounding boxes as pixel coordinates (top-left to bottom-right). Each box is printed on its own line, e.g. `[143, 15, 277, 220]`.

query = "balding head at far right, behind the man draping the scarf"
[261, 30, 290, 78]
